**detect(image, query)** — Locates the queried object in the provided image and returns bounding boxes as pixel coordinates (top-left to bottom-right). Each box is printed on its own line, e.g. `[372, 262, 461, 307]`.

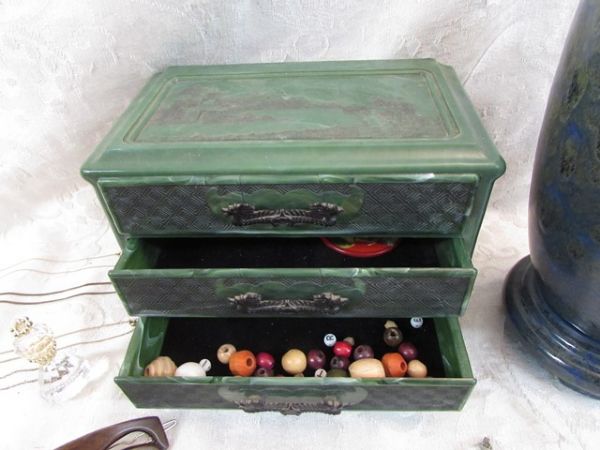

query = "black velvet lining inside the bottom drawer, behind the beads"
[161, 317, 445, 378]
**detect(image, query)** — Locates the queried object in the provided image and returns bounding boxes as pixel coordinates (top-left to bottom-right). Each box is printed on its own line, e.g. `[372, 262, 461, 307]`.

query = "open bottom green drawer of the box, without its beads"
[115, 317, 475, 414]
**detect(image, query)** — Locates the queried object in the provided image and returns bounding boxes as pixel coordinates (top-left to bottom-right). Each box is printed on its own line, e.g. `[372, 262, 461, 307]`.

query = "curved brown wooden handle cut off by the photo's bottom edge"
[56, 416, 169, 450]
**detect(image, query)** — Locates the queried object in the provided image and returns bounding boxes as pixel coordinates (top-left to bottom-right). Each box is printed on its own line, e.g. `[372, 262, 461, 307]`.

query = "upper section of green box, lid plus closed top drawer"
[82, 60, 504, 250]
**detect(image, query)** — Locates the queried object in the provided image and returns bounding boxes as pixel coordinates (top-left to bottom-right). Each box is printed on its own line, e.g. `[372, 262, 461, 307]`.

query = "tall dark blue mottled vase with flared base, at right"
[505, 0, 600, 398]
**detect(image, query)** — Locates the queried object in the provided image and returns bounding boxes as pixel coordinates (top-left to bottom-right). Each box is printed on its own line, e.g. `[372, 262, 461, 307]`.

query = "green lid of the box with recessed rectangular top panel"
[82, 60, 504, 179]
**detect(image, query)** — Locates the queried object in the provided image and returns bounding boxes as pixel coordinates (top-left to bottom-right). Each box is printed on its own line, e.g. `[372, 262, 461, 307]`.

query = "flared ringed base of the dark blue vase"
[504, 256, 600, 399]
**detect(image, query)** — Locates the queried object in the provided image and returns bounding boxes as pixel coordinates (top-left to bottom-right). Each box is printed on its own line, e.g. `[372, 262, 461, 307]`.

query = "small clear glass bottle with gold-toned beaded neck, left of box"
[11, 317, 90, 402]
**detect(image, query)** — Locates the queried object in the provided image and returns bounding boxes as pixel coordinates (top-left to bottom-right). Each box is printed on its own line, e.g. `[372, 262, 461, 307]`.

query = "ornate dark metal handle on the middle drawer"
[229, 292, 348, 314]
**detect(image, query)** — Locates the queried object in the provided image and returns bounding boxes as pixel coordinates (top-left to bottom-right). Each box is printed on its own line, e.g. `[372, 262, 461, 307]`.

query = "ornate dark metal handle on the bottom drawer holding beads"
[235, 395, 344, 416]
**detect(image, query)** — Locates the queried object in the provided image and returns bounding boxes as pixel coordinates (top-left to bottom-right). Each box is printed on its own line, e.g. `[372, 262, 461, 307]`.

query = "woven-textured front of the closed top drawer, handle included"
[99, 175, 477, 237]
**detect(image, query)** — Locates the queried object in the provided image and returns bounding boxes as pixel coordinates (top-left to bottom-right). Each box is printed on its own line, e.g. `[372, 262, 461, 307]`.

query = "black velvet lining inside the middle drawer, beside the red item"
[144, 237, 441, 269]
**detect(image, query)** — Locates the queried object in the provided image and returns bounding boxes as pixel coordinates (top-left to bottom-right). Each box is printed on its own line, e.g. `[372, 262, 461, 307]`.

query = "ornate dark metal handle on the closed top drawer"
[222, 203, 344, 227]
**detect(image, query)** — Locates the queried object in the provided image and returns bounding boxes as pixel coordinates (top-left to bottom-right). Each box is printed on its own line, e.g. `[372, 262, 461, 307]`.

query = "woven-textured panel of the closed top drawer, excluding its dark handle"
[102, 182, 475, 236]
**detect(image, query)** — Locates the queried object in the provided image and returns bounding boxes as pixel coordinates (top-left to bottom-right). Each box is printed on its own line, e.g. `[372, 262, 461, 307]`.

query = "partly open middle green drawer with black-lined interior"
[109, 237, 476, 317]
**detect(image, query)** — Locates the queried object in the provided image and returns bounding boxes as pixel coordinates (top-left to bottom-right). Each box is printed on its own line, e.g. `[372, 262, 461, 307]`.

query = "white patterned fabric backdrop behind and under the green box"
[0, 0, 600, 449]
